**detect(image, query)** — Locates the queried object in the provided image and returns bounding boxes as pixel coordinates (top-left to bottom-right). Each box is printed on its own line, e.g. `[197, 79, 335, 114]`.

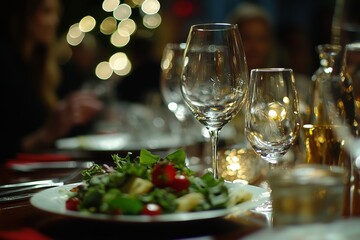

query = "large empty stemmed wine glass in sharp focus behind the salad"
[180, 23, 248, 179]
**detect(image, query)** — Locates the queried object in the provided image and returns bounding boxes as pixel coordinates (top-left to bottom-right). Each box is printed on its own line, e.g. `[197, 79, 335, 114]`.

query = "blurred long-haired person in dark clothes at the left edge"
[0, 0, 102, 162]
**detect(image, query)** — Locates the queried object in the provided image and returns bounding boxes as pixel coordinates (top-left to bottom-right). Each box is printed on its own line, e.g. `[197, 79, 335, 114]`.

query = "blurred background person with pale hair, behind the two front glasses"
[227, 2, 310, 162]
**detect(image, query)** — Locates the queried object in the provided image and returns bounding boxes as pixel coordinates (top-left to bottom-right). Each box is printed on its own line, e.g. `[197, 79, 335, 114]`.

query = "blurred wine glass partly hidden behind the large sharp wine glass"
[160, 43, 192, 142]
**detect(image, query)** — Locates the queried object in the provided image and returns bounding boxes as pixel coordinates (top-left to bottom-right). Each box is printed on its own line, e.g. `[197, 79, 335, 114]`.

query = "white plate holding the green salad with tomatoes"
[30, 183, 270, 223]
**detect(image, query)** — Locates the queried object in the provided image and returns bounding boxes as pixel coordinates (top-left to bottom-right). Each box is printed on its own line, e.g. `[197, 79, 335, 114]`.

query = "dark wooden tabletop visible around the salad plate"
[0, 149, 268, 239]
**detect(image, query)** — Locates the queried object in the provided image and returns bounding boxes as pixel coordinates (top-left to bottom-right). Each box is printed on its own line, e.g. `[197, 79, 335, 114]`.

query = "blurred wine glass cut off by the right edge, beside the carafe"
[324, 42, 360, 216]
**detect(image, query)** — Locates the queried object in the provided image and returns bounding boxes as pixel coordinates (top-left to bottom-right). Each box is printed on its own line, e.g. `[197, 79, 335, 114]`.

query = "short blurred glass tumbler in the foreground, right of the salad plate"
[269, 164, 346, 227]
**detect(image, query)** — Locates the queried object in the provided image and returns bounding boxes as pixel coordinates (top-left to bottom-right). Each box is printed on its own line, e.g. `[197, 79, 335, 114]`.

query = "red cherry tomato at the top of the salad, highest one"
[151, 162, 176, 188]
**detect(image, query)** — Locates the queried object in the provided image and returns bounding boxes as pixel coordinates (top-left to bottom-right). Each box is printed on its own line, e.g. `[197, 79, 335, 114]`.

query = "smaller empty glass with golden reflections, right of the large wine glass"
[245, 68, 301, 167]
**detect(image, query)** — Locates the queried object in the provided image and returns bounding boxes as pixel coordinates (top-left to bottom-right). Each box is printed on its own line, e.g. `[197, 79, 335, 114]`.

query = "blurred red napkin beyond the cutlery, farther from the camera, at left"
[6, 153, 71, 167]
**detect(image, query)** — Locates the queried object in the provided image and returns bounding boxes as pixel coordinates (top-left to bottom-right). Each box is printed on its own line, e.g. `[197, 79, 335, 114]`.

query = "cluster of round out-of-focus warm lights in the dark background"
[66, 0, 161, 80]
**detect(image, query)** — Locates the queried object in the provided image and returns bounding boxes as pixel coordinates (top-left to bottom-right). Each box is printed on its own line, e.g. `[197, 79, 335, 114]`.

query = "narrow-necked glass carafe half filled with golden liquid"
[303, 44, 352, 216]
